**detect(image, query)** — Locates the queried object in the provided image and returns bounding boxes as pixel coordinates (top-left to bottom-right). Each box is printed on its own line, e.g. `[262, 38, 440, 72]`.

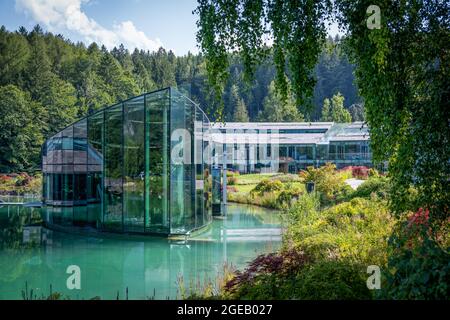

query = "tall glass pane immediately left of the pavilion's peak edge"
[145, 90, 169, 233]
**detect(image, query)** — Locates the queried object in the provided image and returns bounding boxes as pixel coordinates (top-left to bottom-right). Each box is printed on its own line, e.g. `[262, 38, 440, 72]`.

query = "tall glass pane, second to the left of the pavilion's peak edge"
[123, 97, 145, 232]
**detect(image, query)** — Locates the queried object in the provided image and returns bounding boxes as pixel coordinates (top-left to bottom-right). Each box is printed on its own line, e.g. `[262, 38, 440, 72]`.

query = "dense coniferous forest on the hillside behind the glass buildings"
[0, 25, 363, 172]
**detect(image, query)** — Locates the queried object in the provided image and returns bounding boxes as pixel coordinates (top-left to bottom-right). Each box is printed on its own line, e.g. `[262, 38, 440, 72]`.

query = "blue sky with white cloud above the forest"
[0, 0, 342, 55]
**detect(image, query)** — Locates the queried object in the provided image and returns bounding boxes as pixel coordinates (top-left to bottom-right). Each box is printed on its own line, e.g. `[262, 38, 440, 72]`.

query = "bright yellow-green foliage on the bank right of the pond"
[284, 196, 394, 266]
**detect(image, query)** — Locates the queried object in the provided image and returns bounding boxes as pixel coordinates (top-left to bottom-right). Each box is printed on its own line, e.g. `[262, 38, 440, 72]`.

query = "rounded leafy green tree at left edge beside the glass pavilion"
[0, 85, 45, 172]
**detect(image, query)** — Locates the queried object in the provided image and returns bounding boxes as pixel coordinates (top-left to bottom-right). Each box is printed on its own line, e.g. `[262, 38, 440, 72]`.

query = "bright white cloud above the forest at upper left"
[16, 0, 163, 51]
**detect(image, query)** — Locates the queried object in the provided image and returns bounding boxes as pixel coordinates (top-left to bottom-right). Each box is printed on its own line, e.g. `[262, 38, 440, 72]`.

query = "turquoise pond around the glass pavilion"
[0, 204, 281, 299]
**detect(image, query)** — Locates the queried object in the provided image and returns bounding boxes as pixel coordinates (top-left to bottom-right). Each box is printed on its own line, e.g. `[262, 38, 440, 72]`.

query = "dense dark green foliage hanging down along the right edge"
[336, 0, 450, 224]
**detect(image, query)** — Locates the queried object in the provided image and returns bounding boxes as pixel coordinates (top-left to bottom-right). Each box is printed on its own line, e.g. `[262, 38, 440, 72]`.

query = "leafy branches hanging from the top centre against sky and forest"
[194, 0, 332, 119]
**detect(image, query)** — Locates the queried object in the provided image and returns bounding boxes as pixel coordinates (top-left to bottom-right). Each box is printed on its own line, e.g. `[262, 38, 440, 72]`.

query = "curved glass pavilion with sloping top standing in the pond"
[42, 88, 211, 235]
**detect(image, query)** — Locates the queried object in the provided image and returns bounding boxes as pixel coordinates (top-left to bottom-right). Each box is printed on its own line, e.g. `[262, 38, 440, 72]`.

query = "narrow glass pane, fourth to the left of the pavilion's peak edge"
[87, 112, 104, 227]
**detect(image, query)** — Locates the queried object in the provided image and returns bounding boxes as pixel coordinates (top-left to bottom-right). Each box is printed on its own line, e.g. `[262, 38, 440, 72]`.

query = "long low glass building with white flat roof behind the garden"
[210, 122, 373, 173]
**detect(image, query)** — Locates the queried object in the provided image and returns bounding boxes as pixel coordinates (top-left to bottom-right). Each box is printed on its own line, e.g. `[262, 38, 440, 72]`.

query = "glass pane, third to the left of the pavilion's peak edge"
[103, 104, 123, 231]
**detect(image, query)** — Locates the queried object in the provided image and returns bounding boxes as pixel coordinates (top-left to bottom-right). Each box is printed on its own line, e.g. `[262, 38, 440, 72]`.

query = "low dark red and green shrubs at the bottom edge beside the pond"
[224, 250, 371, 300]
